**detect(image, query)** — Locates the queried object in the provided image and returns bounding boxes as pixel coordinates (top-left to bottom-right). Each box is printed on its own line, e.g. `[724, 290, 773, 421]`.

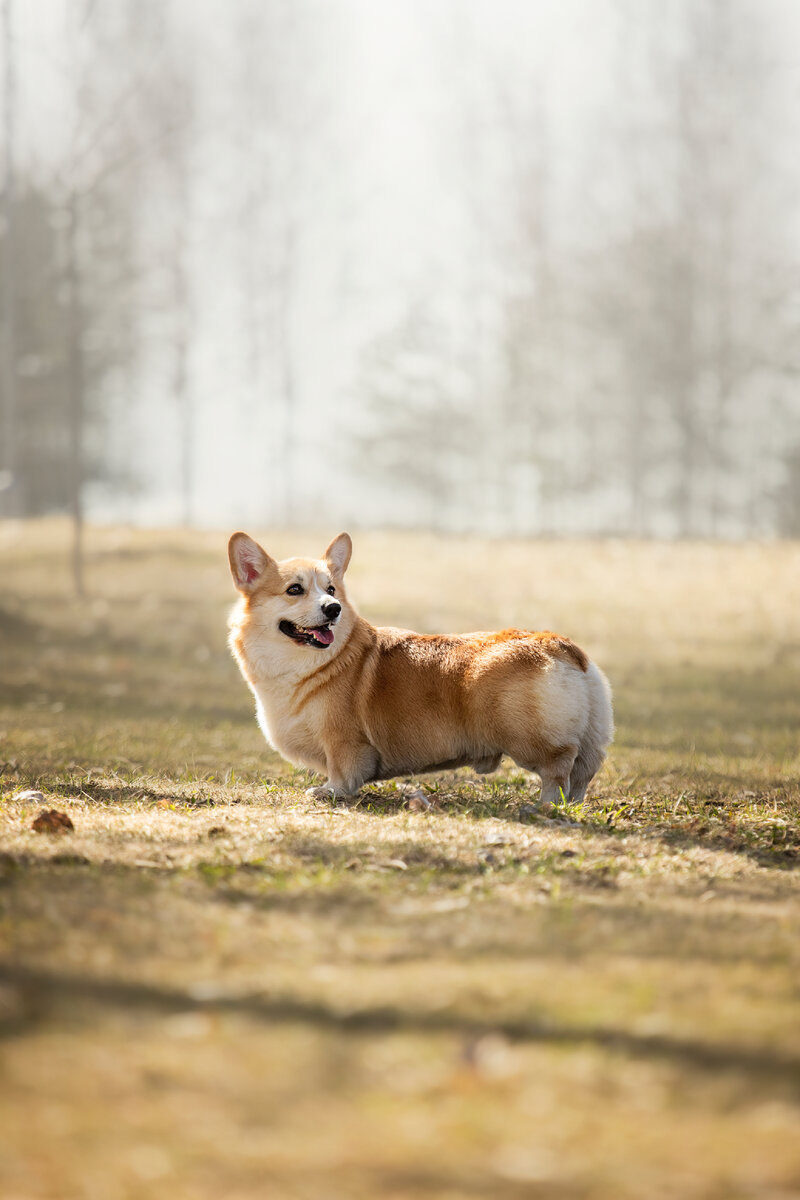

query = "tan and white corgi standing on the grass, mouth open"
[228, 533, 613, 803]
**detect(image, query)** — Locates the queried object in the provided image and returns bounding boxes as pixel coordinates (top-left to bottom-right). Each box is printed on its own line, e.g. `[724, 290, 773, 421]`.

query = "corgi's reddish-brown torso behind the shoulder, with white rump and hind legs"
[359, 629, 613, 800]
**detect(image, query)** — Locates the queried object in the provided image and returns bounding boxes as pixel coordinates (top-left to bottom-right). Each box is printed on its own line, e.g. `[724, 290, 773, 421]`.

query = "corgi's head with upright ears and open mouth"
[228, 533, 353, 658]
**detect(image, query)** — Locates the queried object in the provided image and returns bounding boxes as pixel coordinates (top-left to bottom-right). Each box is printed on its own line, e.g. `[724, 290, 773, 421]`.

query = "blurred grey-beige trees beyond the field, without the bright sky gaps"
[0, 0, 800, 586]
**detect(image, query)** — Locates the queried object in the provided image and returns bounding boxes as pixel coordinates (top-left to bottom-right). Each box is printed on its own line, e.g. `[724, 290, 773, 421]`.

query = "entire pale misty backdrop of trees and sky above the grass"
[0, 0, 800, 538]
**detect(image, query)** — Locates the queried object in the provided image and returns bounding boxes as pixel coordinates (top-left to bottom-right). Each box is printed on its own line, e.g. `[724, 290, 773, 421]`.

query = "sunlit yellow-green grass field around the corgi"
[0, 522, 800, 1200]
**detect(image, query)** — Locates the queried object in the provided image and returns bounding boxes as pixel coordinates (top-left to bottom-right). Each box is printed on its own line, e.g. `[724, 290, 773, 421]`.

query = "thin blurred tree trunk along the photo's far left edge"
[0, 0, 20, 516]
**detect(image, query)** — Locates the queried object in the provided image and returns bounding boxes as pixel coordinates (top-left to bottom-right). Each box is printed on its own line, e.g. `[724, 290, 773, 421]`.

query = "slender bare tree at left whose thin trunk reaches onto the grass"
[34, 0, 182, 580]
